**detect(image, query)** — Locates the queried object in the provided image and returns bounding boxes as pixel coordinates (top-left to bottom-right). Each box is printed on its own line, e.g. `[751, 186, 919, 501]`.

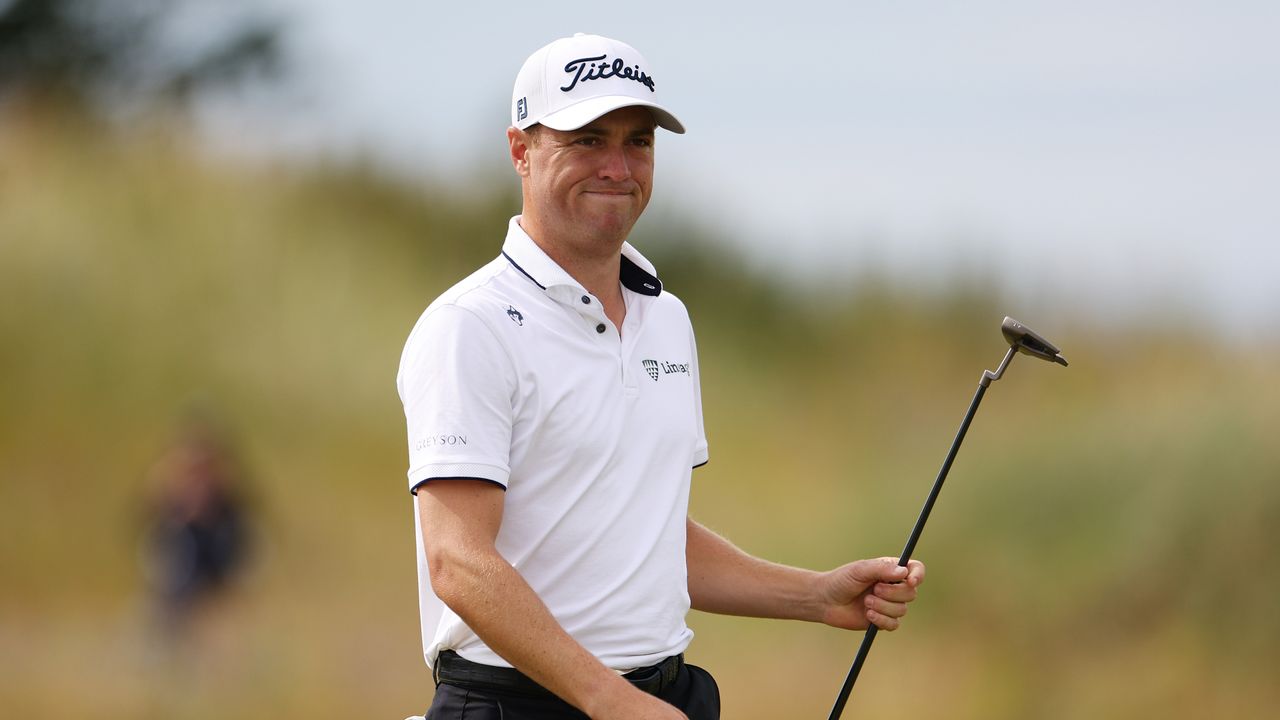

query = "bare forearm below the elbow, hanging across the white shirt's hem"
[431, 543, 634, 716]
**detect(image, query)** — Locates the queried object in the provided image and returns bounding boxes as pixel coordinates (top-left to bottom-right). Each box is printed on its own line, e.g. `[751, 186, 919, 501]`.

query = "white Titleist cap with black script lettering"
[511, 32, 685, 133]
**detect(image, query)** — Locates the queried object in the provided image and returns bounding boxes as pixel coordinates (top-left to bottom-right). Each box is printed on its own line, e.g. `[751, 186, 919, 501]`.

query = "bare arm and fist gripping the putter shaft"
[685, 518, 924, 630]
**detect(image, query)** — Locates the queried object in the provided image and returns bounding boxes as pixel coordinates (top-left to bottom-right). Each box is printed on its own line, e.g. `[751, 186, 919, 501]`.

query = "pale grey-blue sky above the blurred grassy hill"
[199, 0, 1280, 337]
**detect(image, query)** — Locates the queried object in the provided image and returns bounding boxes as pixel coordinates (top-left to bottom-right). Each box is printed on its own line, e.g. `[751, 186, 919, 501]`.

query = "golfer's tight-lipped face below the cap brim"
[508, 108, 654, 258]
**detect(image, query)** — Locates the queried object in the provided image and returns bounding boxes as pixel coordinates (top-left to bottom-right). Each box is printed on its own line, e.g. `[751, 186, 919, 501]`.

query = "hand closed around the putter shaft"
[819, 557, 924, 630]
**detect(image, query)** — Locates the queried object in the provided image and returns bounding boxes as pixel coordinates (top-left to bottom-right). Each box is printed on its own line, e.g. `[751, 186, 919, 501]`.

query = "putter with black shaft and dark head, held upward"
[828, 318, 1066, 720]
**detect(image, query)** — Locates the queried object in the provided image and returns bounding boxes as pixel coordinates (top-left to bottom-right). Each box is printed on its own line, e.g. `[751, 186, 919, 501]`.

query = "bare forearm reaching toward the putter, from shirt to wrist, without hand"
[685, 519, 823, 621]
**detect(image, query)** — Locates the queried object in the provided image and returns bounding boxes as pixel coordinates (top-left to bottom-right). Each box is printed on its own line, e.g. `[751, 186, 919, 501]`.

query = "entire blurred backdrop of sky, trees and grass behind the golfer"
[0, 0, 1280, 719]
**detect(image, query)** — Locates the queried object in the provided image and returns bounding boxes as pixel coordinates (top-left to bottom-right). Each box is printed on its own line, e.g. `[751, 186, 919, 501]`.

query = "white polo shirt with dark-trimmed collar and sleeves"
[397, 217, 707, 670]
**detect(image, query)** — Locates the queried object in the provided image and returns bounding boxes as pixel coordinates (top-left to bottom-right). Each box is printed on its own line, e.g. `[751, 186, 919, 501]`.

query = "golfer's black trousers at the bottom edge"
[426, 665, 719, 720]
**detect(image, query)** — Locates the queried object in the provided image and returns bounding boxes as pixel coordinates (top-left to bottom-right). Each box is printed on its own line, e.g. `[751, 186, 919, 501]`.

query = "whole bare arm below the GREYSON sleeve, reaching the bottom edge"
[417, 479, 685, 720]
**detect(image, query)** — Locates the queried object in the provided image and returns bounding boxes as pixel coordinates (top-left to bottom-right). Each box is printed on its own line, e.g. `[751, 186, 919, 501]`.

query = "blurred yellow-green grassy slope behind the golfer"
[0, 111, 1280, 719]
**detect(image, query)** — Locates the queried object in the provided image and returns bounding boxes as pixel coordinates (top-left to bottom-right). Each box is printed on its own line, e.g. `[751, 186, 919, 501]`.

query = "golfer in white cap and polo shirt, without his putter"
[397, 35, 924, 720]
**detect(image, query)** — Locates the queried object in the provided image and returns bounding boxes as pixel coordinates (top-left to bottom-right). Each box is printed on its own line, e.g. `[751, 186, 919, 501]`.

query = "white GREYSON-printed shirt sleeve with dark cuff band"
[396, 305, 516, 495]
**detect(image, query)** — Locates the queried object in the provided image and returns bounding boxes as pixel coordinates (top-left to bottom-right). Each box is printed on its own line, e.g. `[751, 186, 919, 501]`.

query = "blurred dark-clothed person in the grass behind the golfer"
[142, 410, 251, 647]
